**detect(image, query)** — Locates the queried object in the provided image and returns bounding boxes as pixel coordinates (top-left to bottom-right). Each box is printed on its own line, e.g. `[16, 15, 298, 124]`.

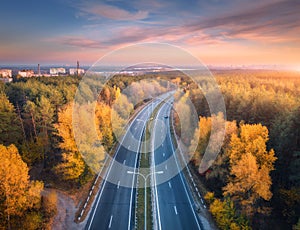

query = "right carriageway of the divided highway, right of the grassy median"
[152, 99, 204, 230]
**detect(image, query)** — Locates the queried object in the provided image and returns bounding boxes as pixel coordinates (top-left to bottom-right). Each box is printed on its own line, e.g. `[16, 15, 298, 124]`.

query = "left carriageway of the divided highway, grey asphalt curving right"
[86, 99, 160, 230]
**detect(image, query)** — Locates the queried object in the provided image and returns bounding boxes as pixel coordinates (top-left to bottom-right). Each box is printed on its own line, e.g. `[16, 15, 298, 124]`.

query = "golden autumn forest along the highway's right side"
[175, 70, 300, 229]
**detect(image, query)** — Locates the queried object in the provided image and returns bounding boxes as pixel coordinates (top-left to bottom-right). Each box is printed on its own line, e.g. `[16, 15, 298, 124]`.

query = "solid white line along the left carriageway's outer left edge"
[88, 103, 152, 229]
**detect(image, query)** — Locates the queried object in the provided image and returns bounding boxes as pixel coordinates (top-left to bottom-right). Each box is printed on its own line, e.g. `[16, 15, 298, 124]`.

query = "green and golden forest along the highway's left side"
[0, 75, 172, 229]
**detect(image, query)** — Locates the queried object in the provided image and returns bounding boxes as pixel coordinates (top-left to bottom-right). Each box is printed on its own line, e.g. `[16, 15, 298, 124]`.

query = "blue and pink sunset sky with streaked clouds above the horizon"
[0, 0, 300, 70]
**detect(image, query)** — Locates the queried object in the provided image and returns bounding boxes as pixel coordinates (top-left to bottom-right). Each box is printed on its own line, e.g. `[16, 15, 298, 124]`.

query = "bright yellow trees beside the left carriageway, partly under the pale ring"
[54, 104, 105, 182]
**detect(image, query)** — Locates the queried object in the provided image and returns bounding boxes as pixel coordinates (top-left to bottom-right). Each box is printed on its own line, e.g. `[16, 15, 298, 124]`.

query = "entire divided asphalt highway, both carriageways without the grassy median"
[85, 94, 204, 230]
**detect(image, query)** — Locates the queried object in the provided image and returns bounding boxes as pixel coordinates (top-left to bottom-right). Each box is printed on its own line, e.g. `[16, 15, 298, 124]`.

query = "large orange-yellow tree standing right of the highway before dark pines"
[224, 124, 276, 216]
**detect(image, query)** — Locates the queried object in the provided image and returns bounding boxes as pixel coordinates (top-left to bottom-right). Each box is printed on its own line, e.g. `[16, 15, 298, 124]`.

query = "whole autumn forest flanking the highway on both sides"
[0, 70, 300, 229]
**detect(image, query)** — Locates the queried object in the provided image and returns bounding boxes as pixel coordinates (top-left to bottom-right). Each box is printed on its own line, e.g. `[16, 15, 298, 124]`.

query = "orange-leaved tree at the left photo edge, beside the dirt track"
[0, 145, 43, 228]
